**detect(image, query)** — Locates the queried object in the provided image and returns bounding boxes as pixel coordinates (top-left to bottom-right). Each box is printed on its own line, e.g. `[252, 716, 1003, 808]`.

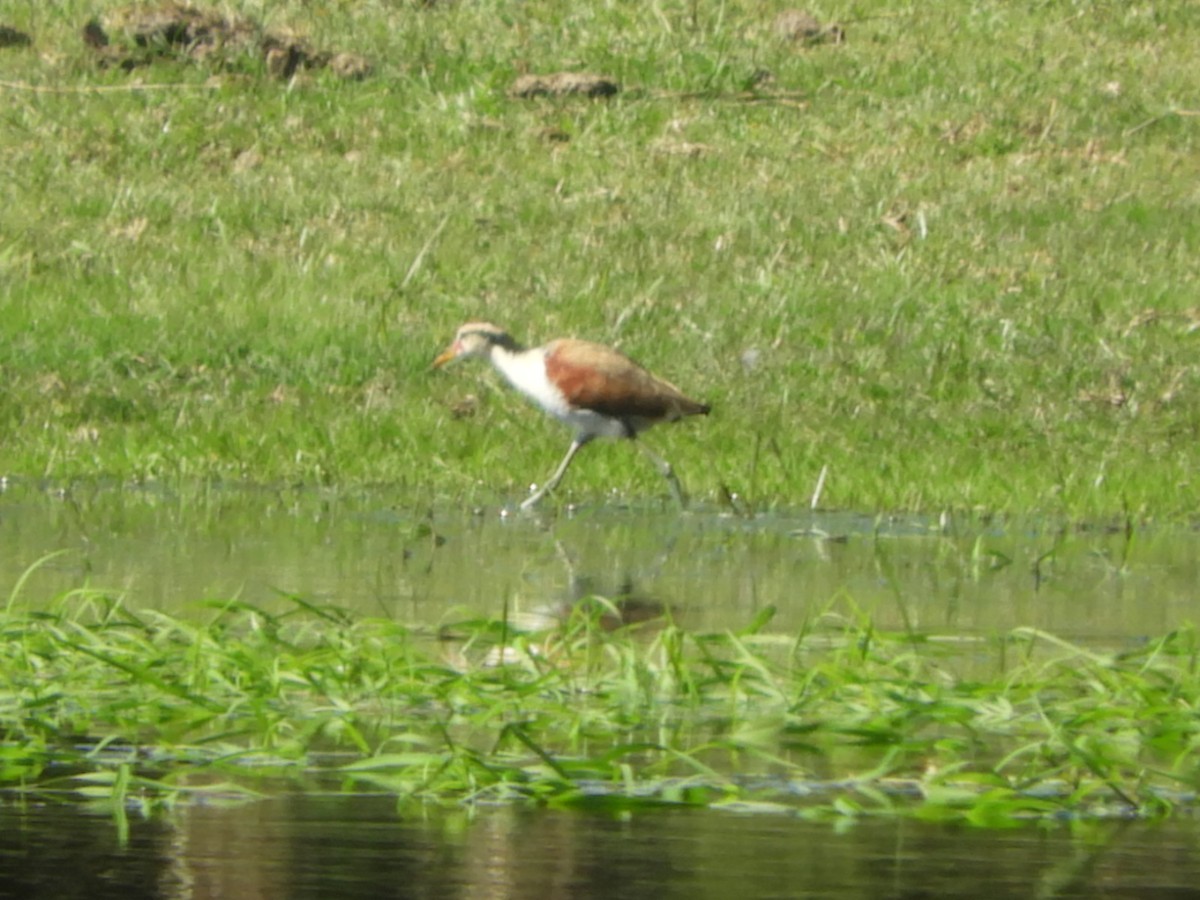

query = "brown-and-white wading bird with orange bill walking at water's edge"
[433, 322, 712, 510]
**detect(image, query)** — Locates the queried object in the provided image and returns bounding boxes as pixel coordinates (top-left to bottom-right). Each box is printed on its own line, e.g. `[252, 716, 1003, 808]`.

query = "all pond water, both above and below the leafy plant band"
[0, 484, 1200, 898]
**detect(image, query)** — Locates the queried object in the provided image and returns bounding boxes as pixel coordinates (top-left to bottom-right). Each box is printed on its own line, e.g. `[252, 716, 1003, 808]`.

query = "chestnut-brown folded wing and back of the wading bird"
[546, 340, 708, 421]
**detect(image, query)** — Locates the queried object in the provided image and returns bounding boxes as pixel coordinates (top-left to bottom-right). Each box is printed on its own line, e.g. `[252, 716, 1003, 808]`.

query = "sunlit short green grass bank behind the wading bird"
[0, 0, 1200, 518]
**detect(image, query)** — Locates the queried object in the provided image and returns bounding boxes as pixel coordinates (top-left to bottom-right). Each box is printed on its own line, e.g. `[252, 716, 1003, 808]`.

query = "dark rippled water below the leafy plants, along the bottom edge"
[0, 796, 1200, 900]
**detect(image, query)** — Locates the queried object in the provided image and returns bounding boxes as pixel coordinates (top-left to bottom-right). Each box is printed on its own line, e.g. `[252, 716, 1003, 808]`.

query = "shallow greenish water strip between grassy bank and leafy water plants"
[0, 484, 1200, 643]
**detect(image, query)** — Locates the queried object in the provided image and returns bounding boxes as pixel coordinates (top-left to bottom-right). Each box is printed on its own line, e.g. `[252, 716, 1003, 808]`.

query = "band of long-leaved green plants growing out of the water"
[0, 592, 1200, 826]
